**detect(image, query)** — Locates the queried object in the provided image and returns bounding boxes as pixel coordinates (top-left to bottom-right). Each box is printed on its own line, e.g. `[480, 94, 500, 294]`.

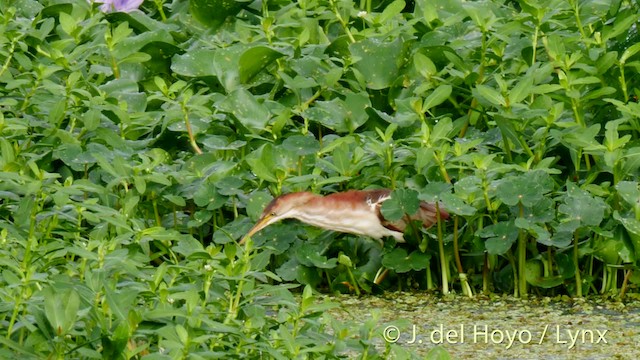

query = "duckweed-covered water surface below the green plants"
[325, 293, 640, 359]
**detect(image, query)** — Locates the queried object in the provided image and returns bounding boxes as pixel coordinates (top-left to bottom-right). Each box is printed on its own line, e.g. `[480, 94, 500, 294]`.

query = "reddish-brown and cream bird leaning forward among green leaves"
[239, 189, 449, 245]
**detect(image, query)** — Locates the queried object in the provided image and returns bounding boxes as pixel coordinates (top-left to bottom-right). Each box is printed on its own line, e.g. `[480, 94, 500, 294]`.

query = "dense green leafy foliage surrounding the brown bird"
[0, 0, 640, 359]
